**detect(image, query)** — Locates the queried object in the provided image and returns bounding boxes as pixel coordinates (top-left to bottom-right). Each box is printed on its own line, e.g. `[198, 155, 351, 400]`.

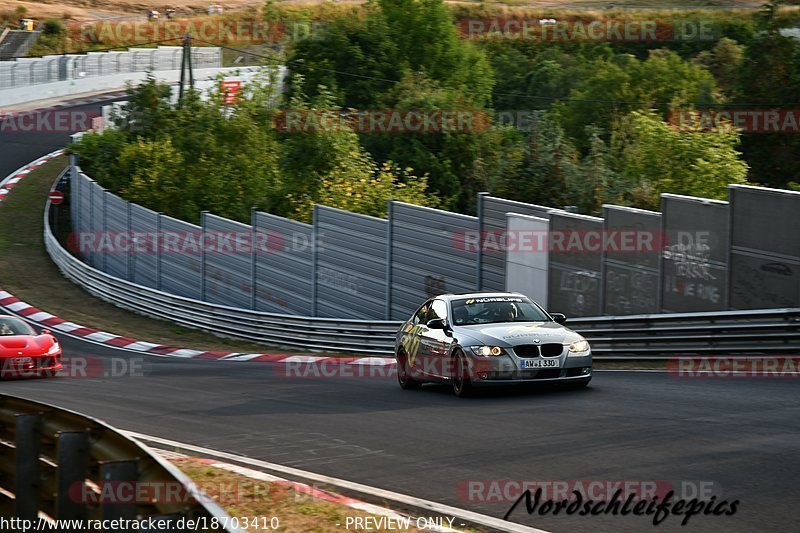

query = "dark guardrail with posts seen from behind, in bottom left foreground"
[0, 394, 243, 533]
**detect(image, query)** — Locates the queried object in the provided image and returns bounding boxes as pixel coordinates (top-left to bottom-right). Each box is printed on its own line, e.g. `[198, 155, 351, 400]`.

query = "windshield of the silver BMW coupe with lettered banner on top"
[451, 296, 550, 326]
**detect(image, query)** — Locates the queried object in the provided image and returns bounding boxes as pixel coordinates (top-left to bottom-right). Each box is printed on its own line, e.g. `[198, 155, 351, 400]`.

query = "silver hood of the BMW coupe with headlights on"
[453, 322, 581, 347]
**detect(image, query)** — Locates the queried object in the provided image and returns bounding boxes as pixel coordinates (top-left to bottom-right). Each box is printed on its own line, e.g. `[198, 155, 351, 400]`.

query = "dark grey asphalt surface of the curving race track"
[0, 95, 800, 533]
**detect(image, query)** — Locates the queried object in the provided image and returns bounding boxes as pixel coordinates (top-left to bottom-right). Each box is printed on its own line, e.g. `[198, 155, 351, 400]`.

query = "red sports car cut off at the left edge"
[0, 315, 61, 378]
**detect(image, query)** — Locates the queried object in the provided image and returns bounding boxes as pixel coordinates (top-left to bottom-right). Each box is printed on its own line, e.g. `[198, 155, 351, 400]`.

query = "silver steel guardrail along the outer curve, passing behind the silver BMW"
[44, 168, 800, 360]
